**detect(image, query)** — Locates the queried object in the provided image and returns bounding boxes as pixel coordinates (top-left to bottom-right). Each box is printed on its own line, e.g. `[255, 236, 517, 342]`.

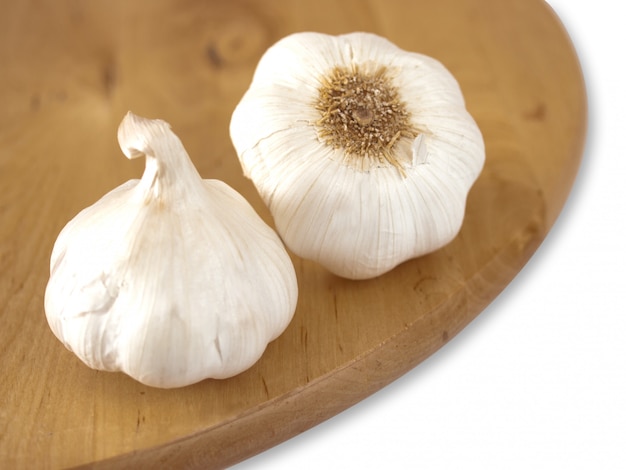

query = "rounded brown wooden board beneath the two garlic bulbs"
[0, 0, 586, 469]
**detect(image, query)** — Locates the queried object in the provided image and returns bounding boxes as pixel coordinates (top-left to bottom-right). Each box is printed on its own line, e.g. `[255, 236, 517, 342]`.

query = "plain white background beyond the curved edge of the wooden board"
[237, 0, 626, 470]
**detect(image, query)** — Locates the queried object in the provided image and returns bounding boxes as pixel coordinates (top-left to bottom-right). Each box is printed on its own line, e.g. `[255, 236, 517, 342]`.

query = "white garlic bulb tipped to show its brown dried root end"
[230, 33, 485, 279]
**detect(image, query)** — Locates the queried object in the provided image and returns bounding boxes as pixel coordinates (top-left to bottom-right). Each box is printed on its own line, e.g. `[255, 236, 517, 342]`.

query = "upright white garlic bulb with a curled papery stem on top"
[45, 113, 298, 388]
